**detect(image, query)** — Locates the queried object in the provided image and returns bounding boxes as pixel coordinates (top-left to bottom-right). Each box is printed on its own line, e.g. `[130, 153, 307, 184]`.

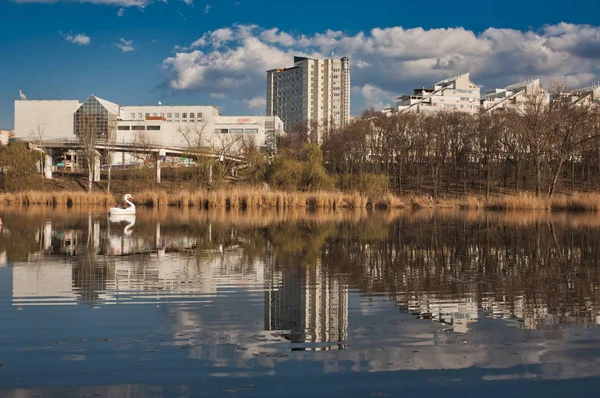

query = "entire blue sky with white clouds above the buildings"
[0, 0, 600, 129]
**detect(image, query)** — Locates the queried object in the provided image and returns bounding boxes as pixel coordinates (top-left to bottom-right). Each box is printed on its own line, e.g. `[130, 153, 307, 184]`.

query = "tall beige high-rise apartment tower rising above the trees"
[267, 57, 350, 141]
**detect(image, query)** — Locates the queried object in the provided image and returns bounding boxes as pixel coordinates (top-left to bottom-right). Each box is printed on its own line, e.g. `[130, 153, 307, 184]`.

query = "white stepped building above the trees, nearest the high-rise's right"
[394, 73, 480, 114]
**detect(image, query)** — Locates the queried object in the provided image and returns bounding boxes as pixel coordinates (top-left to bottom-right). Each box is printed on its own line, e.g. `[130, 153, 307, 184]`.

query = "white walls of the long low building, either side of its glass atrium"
[15, 101, 283, 154]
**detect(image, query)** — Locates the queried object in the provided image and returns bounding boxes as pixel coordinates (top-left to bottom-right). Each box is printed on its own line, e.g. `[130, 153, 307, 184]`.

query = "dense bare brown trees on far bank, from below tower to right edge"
[251, 83, 600, 197]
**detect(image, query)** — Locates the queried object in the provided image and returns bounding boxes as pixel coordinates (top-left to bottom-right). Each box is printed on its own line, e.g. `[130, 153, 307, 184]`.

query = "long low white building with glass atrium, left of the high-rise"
[14, 95, 283, 154]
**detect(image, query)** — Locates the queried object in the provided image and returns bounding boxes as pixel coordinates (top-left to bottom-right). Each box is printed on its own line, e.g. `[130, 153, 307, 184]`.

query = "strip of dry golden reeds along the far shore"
[0, 188, 600, 211]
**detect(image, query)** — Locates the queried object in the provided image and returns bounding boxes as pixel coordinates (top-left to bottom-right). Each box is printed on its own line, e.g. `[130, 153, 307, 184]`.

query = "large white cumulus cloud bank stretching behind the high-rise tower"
[163, 23, 600, 113]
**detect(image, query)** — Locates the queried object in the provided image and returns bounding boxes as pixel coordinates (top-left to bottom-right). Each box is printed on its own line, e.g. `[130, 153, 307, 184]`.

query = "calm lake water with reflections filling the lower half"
[0, 208, 600, 398]
